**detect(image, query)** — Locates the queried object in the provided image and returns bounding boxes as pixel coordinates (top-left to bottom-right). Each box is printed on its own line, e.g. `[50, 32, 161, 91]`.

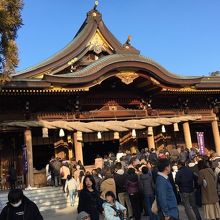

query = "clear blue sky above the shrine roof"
[17, 0, 220, 76]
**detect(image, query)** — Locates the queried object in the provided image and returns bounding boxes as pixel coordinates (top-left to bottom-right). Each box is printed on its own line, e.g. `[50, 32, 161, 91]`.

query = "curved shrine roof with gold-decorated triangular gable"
[5, 9, 220, 90]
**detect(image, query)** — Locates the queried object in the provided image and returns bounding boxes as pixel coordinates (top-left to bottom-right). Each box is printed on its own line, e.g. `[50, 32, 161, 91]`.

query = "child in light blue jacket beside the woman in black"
[103, 191, 127, 220]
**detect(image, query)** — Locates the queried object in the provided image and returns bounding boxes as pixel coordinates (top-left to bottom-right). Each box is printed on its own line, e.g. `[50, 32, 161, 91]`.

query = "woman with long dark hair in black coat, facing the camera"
[78, 175, 103, 220]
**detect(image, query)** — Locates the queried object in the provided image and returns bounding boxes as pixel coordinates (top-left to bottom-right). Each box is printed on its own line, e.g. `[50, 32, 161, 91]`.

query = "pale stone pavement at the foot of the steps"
[42, 204, 202, 220]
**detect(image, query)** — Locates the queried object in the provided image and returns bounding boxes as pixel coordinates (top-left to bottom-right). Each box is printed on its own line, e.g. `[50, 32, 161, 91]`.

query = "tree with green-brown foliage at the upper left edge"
[0, 0, 23, 84]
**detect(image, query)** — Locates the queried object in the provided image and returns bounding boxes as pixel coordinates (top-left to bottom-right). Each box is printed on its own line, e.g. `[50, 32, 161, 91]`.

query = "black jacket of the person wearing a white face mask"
[0, 196, 43, 220]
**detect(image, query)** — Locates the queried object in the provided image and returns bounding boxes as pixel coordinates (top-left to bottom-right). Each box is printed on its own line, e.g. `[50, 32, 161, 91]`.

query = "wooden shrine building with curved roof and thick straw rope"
[0, 8, 220, 186]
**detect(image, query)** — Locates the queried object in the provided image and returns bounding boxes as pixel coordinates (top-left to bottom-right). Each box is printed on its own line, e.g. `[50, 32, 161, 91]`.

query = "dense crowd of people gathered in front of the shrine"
[0, 144, 220, 220]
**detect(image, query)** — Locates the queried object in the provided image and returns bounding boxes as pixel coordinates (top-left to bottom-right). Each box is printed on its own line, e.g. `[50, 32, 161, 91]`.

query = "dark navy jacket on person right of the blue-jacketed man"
[175, 166, 195, 193]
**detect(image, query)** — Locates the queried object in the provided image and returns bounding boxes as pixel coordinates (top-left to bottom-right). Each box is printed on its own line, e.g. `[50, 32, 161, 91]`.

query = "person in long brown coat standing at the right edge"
[198, 160, 220, 219]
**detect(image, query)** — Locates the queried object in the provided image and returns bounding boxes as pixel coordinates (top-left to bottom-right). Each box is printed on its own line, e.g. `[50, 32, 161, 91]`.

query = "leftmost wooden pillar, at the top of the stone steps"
[24, 129, 34, 187]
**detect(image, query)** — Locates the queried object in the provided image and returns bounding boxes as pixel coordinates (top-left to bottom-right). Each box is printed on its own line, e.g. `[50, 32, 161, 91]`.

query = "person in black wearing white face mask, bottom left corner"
[0, 189, 43, 220]
